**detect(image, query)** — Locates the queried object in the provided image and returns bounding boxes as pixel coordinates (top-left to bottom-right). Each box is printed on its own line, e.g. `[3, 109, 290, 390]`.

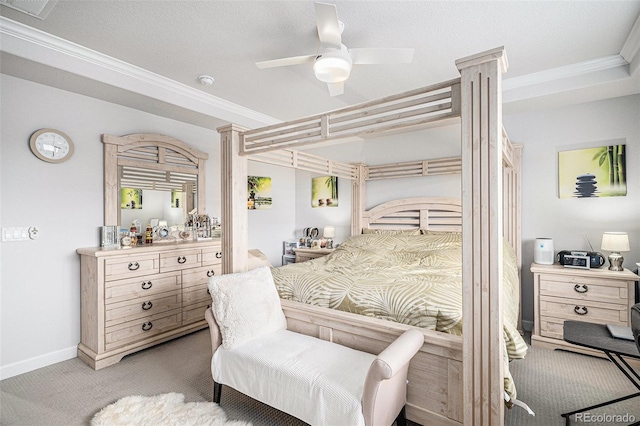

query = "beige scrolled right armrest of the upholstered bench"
[362, 329, 424, 426]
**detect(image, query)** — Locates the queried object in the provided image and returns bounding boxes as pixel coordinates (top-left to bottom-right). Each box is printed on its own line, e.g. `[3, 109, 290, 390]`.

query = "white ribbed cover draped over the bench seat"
[211, 330, 376, 426]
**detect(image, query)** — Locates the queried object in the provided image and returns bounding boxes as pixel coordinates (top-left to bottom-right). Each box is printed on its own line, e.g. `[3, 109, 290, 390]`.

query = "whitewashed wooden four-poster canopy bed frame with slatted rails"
[218, 47, 521, 425]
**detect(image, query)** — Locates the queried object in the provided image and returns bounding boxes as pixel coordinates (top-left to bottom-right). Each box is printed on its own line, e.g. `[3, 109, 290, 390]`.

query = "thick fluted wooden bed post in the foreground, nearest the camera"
[456, 47, 507, 426]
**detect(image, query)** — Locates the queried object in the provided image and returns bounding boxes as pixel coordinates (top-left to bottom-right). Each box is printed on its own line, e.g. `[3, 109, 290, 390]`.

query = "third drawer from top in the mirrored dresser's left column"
[105, 290, 182, 328]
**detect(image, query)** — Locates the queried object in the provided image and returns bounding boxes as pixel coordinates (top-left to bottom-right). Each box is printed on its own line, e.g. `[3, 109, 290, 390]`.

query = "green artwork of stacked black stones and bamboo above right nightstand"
[558, 145, 627, 198]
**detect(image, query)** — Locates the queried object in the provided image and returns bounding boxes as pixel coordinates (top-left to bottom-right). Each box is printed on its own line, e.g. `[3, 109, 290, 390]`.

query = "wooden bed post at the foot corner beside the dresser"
[220, 124, 249, 274]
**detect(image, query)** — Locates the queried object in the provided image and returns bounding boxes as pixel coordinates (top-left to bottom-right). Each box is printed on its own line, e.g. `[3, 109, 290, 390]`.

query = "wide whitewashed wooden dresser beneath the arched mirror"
[77, 240, 222, 370]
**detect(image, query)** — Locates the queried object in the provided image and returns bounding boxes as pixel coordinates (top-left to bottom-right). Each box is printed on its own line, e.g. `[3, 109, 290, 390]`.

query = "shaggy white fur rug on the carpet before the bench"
[91, 393, 251, 426]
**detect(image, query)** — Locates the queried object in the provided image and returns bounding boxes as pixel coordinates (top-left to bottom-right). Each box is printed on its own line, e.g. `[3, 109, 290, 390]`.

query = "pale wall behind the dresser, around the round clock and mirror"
[0, 74, 221, 378]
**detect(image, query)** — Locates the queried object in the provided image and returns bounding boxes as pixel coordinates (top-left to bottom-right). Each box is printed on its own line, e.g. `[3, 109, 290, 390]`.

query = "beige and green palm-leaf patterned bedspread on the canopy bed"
[272, 232, 527, 397]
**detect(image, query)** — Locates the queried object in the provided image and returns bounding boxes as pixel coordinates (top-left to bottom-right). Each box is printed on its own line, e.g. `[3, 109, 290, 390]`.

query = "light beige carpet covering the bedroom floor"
[0, 330, 640, 426]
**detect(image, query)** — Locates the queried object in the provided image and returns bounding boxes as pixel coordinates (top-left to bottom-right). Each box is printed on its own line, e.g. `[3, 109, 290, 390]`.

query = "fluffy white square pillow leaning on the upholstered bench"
[208, 266, 287, 349]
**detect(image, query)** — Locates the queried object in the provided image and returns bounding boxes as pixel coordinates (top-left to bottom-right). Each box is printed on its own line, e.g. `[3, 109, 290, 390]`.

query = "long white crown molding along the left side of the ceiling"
[0, 16, 281, 128]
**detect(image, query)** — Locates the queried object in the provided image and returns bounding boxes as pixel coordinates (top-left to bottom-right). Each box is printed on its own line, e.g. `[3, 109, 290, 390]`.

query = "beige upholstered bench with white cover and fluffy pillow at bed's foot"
[205, 268, 424, 426]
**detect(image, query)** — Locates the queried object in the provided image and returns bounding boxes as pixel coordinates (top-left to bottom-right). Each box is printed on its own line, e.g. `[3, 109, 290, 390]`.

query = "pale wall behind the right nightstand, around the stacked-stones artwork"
[504, 95, 640, 327]
